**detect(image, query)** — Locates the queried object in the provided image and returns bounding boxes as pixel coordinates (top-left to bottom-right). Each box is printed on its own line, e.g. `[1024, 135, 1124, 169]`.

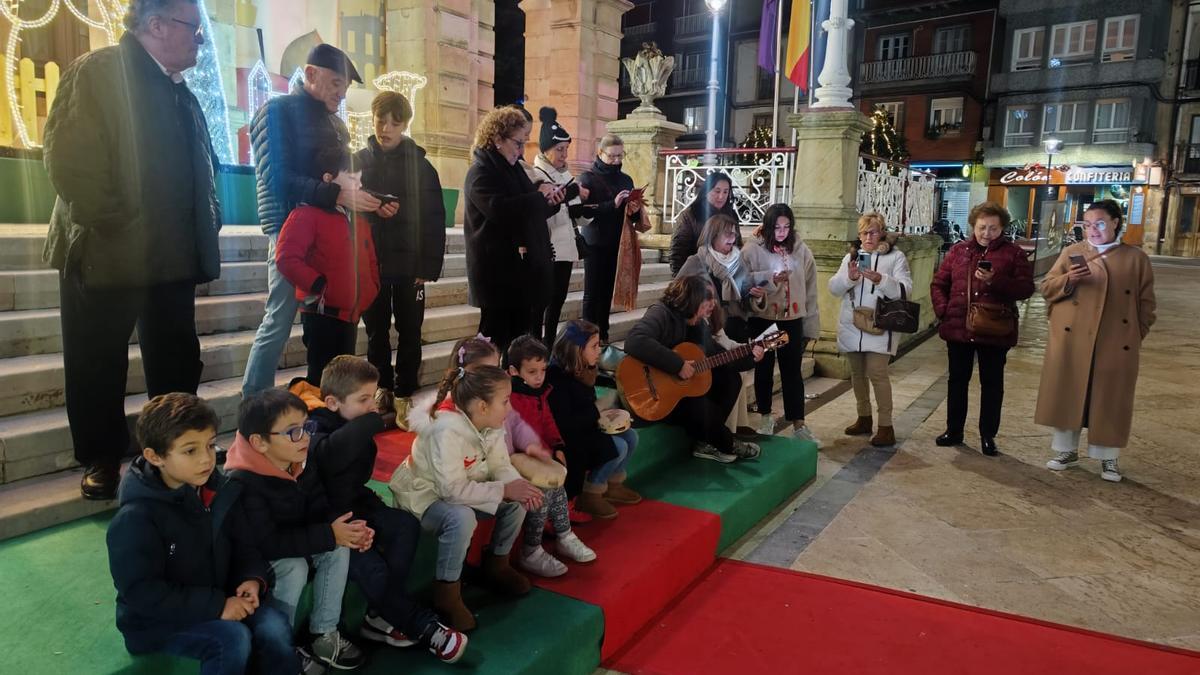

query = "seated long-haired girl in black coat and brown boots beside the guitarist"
[546, 319, 642, 519]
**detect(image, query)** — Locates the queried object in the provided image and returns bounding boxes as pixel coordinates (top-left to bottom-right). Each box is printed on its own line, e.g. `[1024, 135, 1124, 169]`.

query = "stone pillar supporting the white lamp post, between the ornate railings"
[787, 109, 871, 378]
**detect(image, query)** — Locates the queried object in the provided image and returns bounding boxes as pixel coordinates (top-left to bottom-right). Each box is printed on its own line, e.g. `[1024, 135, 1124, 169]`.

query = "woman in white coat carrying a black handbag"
[829, 213, 912, 448]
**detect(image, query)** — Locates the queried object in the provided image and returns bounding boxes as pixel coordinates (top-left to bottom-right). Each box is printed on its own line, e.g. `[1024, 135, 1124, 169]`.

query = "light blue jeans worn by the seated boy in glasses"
[268, 546, 350, 635]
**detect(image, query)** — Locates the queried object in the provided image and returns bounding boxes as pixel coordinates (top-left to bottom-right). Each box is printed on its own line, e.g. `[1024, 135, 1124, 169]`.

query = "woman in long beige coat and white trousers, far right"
[1033, 199, 1154, 482]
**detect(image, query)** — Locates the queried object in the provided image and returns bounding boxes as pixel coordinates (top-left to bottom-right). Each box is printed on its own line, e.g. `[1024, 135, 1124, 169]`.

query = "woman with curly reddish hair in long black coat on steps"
[463, 106, 565, 352]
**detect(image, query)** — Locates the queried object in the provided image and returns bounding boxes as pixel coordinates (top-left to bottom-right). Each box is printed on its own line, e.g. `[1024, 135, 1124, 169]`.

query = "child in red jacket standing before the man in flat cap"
[275, 148, 379, 387]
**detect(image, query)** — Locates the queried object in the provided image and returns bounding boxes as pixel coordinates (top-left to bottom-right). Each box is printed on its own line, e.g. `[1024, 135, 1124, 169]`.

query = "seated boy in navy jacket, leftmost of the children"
[108, 394, 300, 674]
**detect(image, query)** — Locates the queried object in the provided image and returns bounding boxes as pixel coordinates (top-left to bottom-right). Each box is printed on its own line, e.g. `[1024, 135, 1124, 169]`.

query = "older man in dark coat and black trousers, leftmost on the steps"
[43, 0, 221, 500]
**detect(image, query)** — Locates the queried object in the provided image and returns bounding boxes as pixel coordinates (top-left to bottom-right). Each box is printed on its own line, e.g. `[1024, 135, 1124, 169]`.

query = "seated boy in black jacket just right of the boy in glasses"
[308, 354, 467, 663]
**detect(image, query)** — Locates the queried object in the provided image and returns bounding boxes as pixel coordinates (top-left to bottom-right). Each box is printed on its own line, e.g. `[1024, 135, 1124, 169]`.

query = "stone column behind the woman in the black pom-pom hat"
[521, 0, 634, 173]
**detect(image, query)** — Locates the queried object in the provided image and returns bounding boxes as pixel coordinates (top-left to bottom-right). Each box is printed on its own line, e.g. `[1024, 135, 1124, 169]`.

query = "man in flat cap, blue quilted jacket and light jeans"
[241, 44, 386, 396]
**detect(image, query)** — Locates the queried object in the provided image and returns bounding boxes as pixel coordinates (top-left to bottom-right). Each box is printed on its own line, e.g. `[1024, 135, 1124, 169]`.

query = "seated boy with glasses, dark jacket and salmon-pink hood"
[226, 389, 374, 670]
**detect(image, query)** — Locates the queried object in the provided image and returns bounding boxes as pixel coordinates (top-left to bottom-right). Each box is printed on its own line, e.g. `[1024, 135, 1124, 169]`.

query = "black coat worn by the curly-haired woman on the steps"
[463, 148, 559, 307]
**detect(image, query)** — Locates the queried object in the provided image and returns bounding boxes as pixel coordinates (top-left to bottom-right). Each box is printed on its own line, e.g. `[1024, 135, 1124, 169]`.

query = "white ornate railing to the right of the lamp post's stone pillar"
[857, 155, 937, 234]
